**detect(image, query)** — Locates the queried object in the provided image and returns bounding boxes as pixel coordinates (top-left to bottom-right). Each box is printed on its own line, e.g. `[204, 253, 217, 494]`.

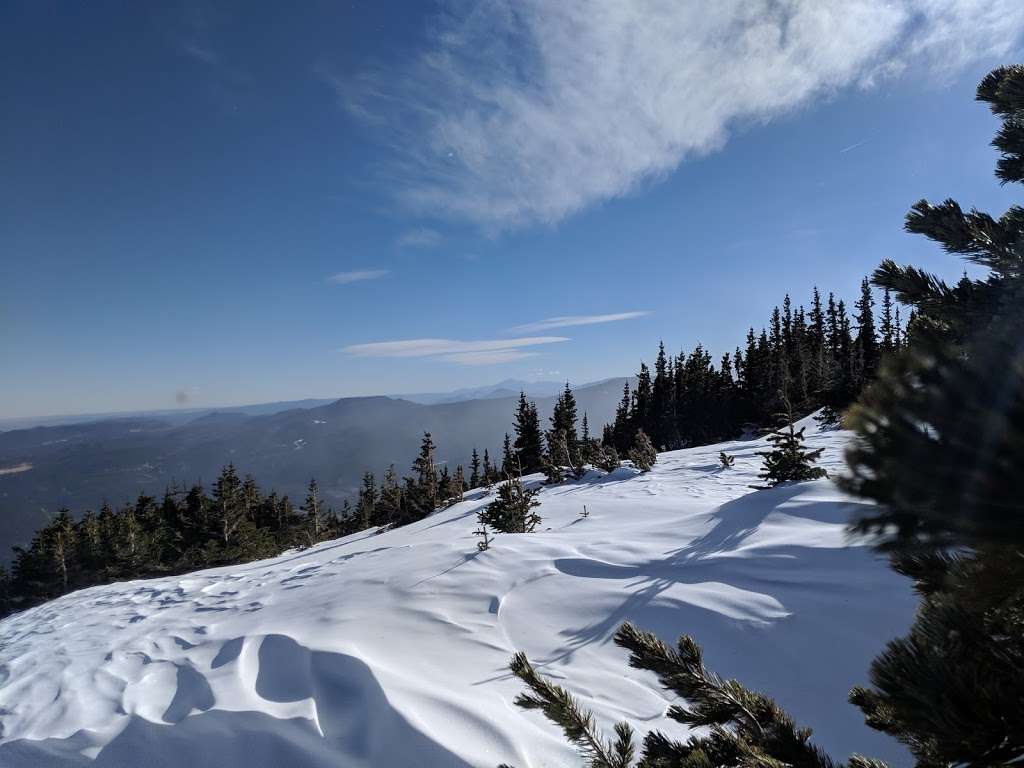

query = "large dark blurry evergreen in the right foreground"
[844, 67, 1024, 768]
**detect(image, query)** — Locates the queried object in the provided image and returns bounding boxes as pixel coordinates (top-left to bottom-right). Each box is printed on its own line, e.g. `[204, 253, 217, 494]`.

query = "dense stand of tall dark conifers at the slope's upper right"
[603, 282, 902, 454]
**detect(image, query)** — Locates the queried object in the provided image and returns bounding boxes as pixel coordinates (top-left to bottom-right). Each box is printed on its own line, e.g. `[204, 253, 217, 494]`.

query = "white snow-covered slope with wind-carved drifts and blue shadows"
[0, 429, 914, 768]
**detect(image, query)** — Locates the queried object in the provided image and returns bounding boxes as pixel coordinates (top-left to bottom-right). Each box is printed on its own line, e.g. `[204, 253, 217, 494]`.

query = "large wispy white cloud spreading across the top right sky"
[348, 0, 1024, 229]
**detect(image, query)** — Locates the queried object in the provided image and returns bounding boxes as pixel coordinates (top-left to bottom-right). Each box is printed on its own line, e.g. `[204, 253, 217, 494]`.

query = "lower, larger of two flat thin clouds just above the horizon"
[342, 336, 569, 366]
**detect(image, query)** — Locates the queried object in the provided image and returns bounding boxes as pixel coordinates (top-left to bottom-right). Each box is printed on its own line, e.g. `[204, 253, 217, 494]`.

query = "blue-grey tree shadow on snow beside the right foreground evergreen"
[535, 485, 916, 763]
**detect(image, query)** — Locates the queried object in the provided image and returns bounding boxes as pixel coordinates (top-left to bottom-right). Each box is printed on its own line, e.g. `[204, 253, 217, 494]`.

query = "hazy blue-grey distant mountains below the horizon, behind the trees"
[0, 378, 625, 562]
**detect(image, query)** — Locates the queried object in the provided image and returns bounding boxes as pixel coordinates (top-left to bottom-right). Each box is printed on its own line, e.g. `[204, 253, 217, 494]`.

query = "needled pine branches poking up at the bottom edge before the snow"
[503, 624, 885, 768]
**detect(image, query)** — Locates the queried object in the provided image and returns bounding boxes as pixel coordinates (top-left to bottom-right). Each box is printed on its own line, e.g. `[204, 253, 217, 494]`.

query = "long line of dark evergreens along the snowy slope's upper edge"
[0, 281, 906, 614]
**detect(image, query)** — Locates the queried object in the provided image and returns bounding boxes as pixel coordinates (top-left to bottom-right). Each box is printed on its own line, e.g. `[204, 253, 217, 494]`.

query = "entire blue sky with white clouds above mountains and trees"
[0, 0, 1024, 418]
